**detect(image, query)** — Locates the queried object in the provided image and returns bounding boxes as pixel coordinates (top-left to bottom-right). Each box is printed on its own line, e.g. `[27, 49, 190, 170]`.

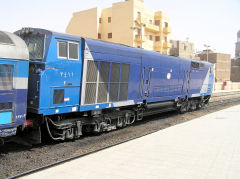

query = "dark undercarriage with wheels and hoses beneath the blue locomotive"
[17, 96, 210, 144]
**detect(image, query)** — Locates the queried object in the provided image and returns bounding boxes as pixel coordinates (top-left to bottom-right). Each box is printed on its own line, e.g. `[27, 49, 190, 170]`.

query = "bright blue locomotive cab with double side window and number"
[17, 28, 82, 115]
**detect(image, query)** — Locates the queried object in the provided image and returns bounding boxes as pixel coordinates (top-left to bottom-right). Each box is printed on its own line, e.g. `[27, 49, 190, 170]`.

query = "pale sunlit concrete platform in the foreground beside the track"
[21, 105, 240, 179]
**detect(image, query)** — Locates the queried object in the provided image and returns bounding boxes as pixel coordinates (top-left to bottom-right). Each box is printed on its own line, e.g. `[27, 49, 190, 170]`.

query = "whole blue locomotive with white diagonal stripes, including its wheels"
[0, 28, 214, 143]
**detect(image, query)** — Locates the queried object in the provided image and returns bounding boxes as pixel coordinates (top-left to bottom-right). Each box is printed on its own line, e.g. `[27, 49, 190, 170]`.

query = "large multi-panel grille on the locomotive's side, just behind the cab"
[83, 60, 130, 104]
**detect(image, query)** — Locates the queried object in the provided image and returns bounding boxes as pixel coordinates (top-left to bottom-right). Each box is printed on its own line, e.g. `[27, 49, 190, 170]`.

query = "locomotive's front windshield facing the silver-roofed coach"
[21, 34, 45, 61]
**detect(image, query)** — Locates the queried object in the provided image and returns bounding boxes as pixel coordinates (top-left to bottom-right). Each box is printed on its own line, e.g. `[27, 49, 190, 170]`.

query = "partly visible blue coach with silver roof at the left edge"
[0, 31, 29, 142]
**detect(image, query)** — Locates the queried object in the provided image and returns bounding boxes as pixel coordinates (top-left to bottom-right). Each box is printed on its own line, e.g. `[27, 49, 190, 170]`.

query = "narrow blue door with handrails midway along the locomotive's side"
[141, 67, 153, 99]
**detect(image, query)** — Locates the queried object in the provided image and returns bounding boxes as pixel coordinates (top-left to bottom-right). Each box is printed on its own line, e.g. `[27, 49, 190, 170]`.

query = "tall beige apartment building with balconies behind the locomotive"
[66, 0, 171, 54]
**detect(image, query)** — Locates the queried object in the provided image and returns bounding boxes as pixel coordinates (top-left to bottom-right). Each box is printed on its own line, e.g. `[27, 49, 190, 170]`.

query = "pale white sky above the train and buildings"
[0, 0, 240, 57]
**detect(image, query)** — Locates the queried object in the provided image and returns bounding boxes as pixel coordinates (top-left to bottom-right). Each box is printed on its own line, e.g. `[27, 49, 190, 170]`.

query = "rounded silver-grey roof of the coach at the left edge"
[0, 31, 29, 60]
